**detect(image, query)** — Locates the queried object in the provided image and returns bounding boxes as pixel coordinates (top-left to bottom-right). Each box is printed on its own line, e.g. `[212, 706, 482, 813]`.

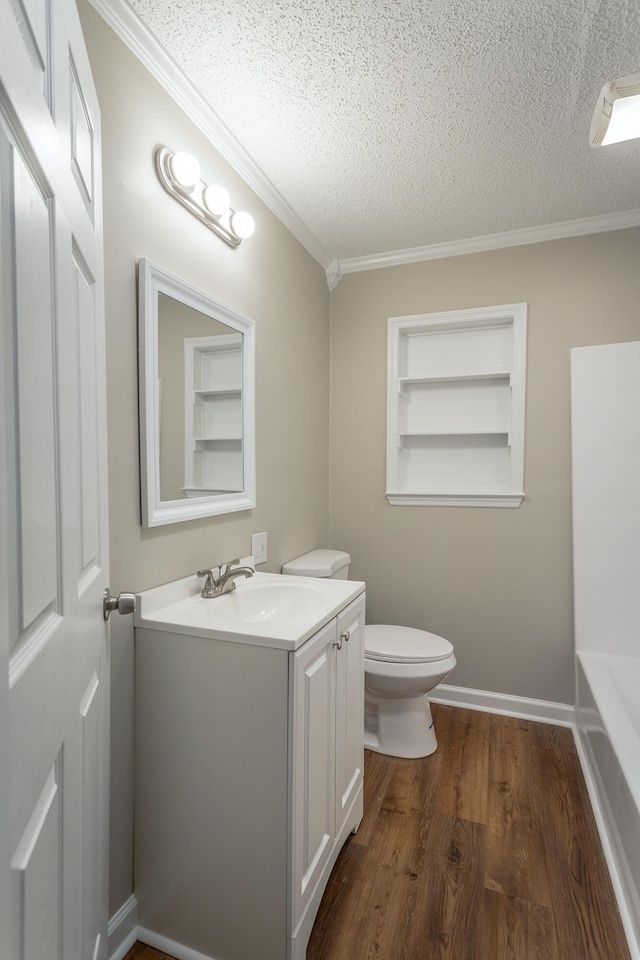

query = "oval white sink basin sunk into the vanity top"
[185, 577, 326, 627]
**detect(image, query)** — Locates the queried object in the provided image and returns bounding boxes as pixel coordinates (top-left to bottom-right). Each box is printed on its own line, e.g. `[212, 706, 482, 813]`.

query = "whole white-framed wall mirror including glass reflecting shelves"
[138, 260, 256, 527]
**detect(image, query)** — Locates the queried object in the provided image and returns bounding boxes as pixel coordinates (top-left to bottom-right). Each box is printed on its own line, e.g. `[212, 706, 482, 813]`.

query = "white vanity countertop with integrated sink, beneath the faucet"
[134, 557, 364, 650]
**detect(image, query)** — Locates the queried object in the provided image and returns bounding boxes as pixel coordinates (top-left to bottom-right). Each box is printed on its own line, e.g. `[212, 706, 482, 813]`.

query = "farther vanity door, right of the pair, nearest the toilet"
[336, 596, 365, 834]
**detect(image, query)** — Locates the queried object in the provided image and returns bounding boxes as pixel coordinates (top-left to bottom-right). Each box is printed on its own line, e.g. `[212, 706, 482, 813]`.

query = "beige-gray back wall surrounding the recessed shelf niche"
[331, 229, 640, 703]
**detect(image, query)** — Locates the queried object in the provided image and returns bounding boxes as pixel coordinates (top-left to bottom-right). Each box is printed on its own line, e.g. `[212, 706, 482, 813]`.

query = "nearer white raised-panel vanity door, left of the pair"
[291, 620, 338, 928]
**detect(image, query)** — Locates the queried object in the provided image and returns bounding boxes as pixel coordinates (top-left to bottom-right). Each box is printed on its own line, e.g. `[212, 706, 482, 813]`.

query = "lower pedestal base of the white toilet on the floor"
[364, 692, 438, 760]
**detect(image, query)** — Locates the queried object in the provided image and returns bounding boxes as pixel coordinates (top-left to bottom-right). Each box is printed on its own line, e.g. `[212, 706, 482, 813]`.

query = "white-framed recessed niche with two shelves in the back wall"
[386, 304, 526, 507]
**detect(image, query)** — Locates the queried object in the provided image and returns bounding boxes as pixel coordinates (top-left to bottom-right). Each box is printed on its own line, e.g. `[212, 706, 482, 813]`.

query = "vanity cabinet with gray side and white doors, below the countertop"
[135, 578, 365, 960]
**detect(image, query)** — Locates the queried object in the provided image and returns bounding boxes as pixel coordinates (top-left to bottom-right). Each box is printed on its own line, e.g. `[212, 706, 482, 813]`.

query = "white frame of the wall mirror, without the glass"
[138, 259, 256, 527]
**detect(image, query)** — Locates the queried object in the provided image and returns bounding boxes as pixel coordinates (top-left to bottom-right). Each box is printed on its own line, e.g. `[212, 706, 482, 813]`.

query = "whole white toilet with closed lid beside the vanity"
[282, 550, 456, 758]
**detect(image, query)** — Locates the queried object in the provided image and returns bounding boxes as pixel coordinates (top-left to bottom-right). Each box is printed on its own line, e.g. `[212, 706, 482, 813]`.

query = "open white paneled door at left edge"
[0, 0, 108, 960]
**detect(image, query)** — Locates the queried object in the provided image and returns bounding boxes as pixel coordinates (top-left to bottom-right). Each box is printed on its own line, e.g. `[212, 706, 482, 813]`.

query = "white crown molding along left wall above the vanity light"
[88, 0, 333, 270]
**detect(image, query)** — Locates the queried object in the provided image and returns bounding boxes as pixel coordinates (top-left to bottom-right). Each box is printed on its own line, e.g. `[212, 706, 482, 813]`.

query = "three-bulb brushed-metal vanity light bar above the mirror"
[154, 147, 255, 247]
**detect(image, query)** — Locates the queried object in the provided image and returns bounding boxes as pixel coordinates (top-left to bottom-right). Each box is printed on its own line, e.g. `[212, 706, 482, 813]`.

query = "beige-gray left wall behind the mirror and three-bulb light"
[80, 3, 329, 914]
